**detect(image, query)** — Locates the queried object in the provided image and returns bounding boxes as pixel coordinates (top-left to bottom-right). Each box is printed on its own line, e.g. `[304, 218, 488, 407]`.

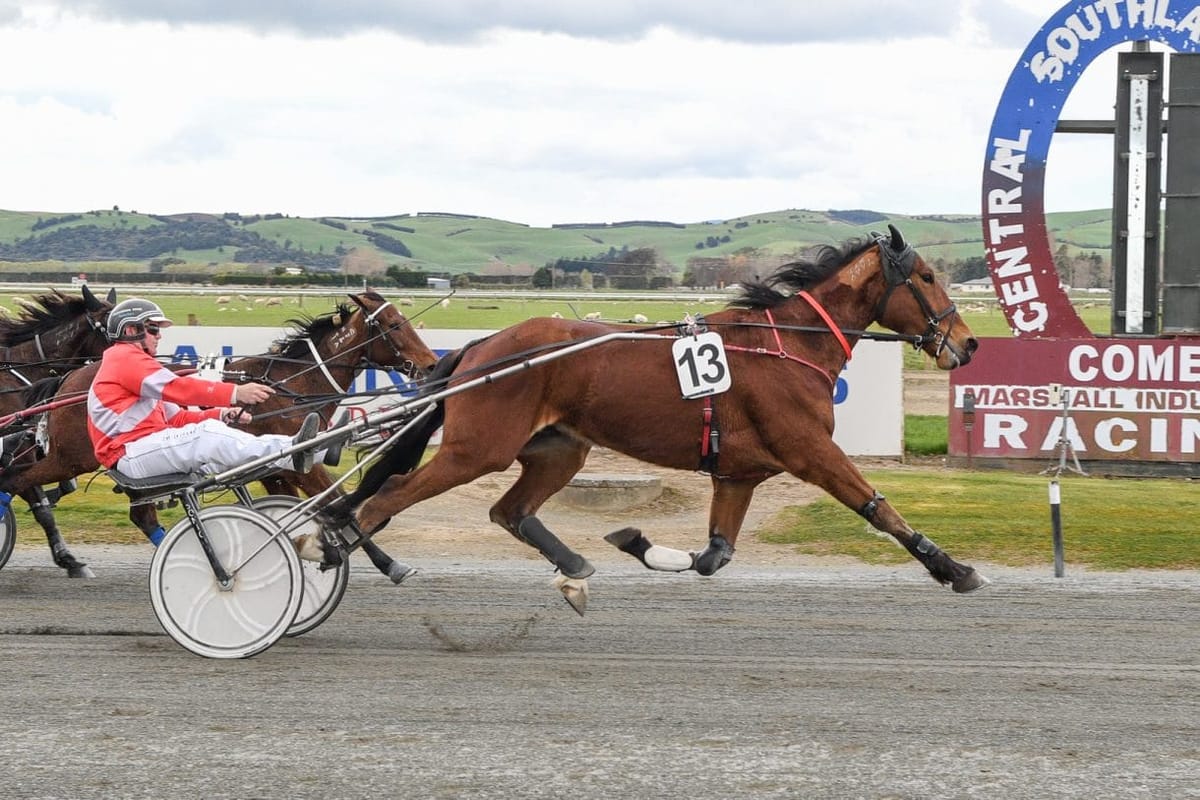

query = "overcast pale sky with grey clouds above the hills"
[0, 0, 1132, 225]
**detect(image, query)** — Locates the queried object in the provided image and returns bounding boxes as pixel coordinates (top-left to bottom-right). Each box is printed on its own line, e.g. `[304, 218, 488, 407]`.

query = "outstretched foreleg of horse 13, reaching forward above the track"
[790, 440, 990, 594]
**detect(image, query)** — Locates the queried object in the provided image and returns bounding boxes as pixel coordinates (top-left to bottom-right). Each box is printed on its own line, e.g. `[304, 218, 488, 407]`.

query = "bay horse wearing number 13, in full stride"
[323, 228, 988, 613]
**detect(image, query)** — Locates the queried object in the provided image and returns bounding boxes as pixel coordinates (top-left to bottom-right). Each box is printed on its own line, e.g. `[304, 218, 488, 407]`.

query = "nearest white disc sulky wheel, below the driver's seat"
[150, 505, 304, 658]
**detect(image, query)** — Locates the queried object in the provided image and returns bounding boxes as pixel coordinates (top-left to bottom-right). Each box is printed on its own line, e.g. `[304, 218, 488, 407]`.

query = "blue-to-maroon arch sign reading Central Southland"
[983, 0, 1200, 338]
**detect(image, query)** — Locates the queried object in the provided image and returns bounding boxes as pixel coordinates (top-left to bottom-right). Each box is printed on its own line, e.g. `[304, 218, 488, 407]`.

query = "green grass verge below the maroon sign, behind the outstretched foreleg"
[758, 469, 1200, 571]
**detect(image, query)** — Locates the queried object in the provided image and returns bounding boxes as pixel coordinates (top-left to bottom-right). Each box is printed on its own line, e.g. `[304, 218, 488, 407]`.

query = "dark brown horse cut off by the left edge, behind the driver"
[0, 285, 116, 578]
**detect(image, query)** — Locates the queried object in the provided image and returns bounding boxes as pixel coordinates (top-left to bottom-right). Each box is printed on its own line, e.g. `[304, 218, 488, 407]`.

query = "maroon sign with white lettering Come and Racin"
[949, 338, 1200, 463]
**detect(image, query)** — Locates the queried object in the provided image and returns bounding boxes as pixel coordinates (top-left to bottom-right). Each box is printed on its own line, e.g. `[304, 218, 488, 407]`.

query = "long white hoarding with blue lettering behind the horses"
[158, 325, 904, 457]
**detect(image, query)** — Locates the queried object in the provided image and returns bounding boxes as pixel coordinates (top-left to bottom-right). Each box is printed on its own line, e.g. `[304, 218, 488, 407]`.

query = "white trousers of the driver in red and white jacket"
[116, 420, 302, 477]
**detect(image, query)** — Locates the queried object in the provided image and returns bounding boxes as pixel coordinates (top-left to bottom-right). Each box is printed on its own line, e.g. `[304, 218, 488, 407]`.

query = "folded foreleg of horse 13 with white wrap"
[605, 476, 762, 576]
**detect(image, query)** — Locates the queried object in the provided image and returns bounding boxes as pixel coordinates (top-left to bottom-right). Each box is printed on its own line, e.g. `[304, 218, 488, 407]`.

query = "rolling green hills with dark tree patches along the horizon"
[0, 209, 1111, 275]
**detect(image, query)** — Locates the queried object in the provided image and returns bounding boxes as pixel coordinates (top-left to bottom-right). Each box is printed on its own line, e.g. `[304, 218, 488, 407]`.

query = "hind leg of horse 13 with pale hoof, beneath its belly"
[488, 428, 595, 616]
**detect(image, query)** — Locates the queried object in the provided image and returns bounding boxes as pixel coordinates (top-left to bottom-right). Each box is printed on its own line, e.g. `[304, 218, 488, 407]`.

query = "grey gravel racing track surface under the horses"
[0, 546, 1200, 800]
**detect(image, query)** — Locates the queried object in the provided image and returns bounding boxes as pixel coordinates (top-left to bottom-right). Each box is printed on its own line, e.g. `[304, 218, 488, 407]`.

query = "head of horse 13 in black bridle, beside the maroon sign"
[875, 224, 979, 369]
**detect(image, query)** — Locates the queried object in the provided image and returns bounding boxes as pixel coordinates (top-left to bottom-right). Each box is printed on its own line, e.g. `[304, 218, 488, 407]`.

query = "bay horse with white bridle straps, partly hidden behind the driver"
[0, 291, 437, 583]
